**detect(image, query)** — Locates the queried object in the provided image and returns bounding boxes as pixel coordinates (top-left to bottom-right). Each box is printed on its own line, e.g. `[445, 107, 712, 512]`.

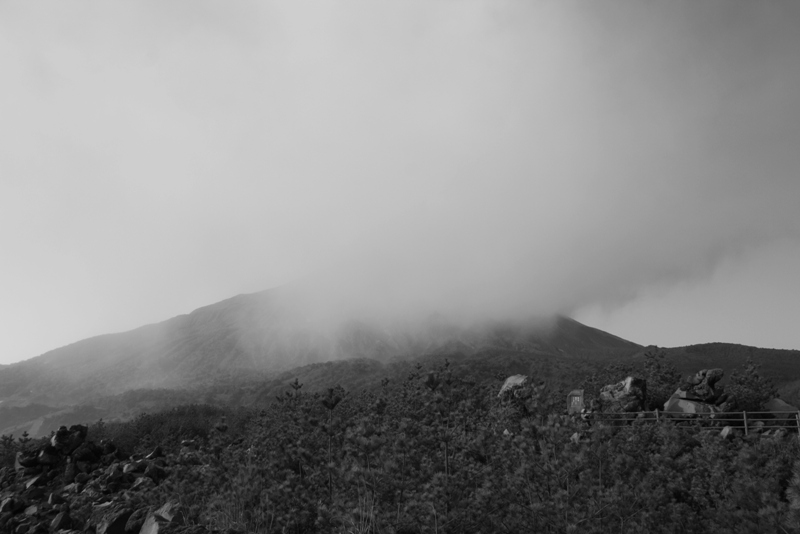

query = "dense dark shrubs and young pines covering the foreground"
[36, 368, 800, 533]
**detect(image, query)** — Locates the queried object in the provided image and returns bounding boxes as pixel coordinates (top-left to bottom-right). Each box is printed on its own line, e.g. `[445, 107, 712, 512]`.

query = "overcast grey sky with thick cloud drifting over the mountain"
[0, 0, 800, 363]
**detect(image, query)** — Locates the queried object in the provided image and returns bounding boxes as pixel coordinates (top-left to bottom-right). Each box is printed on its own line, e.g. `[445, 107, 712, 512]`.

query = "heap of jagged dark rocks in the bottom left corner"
[0, 425, 225, 534]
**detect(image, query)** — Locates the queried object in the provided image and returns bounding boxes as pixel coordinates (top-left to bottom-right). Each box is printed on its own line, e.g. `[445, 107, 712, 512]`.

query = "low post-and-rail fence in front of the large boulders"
[585, 410, 800, 435]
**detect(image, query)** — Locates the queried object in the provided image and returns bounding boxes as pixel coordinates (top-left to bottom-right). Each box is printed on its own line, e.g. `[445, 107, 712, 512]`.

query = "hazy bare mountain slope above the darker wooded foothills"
[0, 289, 641, 406]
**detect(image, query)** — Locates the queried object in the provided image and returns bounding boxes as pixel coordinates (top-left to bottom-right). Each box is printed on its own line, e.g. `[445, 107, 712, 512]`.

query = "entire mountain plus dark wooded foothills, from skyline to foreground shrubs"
[0, 289, 800, 434]
